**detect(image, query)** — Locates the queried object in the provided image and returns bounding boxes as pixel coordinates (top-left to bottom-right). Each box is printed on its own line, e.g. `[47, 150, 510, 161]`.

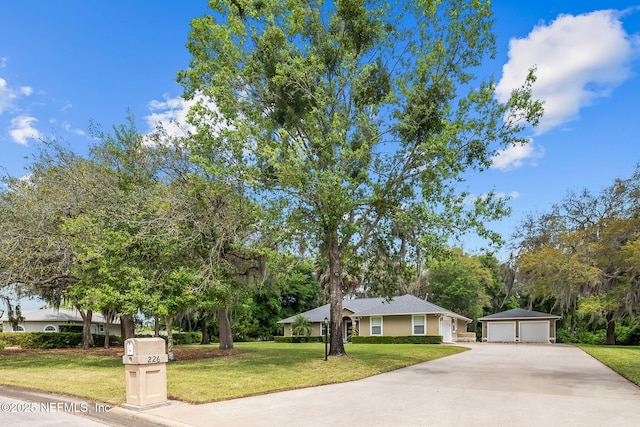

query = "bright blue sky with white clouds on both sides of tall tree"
[0, 0, 640, 260]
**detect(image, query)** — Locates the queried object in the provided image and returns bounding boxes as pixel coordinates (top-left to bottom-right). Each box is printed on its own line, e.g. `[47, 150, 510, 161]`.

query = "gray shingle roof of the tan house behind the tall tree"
[278, 295, 471, 323]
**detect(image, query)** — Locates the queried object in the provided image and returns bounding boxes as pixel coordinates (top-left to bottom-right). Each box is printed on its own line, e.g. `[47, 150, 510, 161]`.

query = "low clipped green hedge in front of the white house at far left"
[0, 332, 120, 349]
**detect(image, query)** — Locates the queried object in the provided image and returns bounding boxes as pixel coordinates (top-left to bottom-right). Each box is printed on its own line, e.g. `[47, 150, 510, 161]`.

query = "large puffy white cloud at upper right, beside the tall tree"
[496, 10, 640, 134]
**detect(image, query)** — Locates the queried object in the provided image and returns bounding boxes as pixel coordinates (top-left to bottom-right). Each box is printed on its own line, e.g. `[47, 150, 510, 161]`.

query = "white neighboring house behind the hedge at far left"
[0, 308, 120, 335]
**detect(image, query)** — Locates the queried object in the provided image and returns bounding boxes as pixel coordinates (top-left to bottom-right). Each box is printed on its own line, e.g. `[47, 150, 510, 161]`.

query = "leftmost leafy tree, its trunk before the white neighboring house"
[0, 142, 115, 349]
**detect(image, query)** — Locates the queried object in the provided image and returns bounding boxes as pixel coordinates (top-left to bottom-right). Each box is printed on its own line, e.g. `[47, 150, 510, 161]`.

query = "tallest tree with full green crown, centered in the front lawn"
[178, 0, 541, 355]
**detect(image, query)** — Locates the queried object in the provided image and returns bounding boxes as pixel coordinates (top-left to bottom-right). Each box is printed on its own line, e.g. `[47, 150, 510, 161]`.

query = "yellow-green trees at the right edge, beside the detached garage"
[512, 167, 640, 345]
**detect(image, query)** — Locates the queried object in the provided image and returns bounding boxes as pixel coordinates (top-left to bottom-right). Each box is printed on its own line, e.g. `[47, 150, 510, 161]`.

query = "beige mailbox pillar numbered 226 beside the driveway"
[122, 338, 168, 409]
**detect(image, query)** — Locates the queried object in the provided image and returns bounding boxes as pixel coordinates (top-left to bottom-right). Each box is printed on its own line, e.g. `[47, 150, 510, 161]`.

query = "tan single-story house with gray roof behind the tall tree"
[278, 295, 475, 342]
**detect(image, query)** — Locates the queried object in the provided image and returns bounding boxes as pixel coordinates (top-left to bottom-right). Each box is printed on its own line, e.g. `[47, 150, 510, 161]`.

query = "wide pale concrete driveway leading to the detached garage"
[140, 343, 640, 427]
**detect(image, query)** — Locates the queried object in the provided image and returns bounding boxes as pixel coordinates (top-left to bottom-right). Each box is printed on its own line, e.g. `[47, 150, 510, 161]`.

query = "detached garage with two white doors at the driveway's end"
[478, 308, 560, 343]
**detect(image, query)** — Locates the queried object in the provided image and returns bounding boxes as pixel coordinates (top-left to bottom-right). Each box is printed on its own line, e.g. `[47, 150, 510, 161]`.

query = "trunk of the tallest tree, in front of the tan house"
[329, 242, 347, 356]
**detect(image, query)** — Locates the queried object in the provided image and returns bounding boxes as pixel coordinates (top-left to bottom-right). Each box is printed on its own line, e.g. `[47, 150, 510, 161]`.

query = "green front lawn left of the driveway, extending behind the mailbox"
[0, 342, 465, 405]
